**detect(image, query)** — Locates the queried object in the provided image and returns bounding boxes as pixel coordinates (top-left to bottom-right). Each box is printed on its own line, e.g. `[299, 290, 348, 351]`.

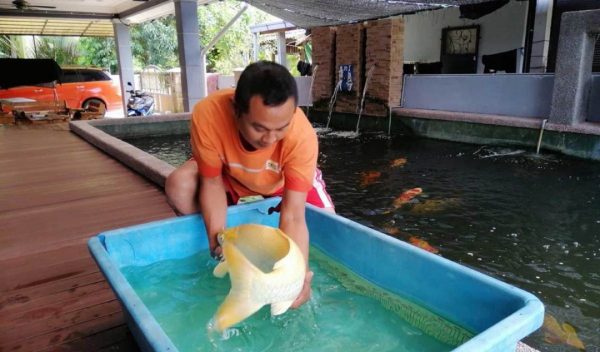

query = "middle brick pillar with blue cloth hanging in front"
[335, 24, 363, 114]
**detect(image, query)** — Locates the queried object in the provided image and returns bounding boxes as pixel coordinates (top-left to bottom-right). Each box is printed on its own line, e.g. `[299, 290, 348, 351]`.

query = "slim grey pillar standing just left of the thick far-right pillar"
[529, 0, 554, 73]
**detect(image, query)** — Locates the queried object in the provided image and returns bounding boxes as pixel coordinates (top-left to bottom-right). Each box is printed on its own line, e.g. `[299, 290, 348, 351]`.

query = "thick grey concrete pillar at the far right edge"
[550, 10, 600, 125]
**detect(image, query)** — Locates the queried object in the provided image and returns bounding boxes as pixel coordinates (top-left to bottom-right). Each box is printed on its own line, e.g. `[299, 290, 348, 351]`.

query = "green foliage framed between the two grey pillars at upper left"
[130, 16, 179, 69]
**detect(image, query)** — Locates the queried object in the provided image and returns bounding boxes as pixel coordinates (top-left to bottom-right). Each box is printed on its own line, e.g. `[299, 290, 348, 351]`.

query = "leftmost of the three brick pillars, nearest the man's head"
[311, 27, 337, 110]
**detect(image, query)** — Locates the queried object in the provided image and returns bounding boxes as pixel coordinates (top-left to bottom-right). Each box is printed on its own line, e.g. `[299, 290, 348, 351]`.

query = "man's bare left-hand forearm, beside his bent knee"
[198, 175, 227, 257]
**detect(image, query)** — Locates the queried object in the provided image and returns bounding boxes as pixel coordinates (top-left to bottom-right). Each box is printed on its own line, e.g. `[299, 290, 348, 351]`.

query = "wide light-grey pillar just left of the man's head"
[173, 0, 206, 112]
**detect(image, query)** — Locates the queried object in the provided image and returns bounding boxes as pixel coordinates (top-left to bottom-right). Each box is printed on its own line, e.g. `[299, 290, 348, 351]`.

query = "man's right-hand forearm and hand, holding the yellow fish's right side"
[279, 189, 313, 308]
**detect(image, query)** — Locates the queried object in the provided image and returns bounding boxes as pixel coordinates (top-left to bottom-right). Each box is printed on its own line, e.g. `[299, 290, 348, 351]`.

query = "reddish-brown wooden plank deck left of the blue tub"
[0, 124, 174, 352]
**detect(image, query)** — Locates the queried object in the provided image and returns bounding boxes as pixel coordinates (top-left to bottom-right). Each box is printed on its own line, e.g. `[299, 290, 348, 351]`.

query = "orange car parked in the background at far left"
[0, 67, 123, 116]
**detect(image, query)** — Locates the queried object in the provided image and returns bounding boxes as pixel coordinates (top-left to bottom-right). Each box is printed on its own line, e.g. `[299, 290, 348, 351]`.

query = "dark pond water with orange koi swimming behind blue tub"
[127, 131, 600, 351]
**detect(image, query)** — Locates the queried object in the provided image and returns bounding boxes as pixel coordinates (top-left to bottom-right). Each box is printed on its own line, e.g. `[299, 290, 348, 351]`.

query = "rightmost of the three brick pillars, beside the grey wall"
[361, 18, 404, 116]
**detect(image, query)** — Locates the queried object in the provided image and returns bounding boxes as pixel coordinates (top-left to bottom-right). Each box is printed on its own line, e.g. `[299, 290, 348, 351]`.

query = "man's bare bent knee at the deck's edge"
[165, 159, 199, 215]
